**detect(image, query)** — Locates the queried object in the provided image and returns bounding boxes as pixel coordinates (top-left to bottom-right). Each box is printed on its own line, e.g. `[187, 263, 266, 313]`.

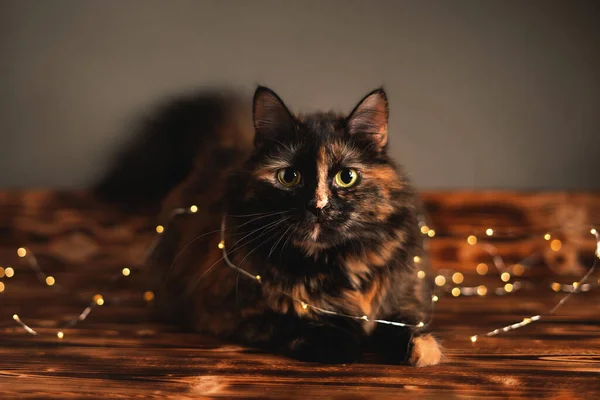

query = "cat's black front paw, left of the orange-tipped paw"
[289, 329, 362, 364]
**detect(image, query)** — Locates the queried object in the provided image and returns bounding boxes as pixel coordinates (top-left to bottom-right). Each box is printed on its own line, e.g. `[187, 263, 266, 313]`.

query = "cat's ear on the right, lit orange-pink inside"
[347, 88, 389, 151]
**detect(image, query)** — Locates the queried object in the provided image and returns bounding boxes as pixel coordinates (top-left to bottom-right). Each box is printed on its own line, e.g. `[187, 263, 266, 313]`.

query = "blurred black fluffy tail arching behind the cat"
[92, 91, 249, 208]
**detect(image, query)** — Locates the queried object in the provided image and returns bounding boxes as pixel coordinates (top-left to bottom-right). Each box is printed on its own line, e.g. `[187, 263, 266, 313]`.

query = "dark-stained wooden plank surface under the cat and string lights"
[0, 191, 600, 399]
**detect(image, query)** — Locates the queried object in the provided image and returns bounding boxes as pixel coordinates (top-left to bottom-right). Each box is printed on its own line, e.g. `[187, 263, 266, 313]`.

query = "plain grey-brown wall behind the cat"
[0, 0, 600, 189]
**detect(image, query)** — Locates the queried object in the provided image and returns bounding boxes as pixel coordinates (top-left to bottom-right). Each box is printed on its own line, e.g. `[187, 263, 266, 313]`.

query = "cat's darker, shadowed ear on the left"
[252, 86, 294, 144]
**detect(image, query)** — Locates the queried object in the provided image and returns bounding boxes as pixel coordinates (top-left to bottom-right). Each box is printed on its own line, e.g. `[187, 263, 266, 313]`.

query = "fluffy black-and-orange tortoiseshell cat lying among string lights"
[95, 87, 441, 366]
